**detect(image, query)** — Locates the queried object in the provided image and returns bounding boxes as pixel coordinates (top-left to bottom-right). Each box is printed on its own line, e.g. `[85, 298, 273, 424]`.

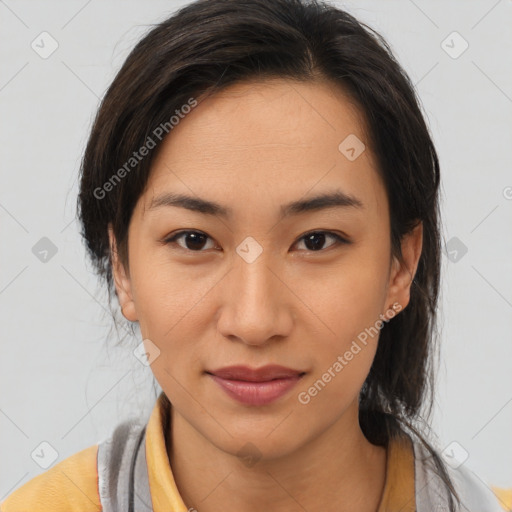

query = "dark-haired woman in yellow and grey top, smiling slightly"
[2, 0, 501, 512]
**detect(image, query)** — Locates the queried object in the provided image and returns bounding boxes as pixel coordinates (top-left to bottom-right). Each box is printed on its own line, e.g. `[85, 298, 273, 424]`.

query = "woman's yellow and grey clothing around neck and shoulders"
[0, 392, 504, 512]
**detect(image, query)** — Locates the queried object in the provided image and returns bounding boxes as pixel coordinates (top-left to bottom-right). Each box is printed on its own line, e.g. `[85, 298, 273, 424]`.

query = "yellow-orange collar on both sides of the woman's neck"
[146, 391, 416, 512]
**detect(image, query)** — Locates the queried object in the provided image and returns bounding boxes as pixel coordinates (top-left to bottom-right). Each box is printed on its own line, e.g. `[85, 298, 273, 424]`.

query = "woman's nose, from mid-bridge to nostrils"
[217, 255, 295, 345]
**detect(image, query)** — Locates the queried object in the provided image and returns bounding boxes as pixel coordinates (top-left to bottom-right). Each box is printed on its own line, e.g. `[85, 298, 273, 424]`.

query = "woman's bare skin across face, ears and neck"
[110, 79, 422, 512]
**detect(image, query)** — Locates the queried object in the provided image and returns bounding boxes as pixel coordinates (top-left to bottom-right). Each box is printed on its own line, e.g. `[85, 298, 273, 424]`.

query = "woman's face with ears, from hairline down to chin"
[111, 80, 421, 458]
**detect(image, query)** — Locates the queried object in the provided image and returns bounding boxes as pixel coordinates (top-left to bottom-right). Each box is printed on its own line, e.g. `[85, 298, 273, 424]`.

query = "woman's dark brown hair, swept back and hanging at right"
[78, 0, 456, 504]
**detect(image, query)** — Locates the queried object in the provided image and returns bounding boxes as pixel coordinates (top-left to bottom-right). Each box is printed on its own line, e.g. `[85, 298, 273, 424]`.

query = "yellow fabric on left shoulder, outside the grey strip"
[0, 445, 102, 512]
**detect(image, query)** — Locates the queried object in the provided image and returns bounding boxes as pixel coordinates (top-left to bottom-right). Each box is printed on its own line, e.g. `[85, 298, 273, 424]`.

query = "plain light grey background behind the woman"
[0, 0, 512, 500]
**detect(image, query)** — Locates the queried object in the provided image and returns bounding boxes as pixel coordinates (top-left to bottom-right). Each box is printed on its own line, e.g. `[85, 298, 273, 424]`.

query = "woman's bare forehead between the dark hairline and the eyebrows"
[138, 79, 385, 219]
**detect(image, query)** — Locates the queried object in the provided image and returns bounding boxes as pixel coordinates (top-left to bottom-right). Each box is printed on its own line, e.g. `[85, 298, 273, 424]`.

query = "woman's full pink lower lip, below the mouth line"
[209, 374, 301, 405]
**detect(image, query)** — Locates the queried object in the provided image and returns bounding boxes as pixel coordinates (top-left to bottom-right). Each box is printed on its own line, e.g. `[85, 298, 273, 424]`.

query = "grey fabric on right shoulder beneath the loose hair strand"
[413, 440, 504, 512]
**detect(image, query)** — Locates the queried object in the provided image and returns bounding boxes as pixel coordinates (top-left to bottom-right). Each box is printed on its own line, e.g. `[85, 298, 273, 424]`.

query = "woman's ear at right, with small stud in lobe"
[386, 222, 423, 311]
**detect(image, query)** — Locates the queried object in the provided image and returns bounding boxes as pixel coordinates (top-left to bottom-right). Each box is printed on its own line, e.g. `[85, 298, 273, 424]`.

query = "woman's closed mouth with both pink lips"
[206, 365, 306, 406]
